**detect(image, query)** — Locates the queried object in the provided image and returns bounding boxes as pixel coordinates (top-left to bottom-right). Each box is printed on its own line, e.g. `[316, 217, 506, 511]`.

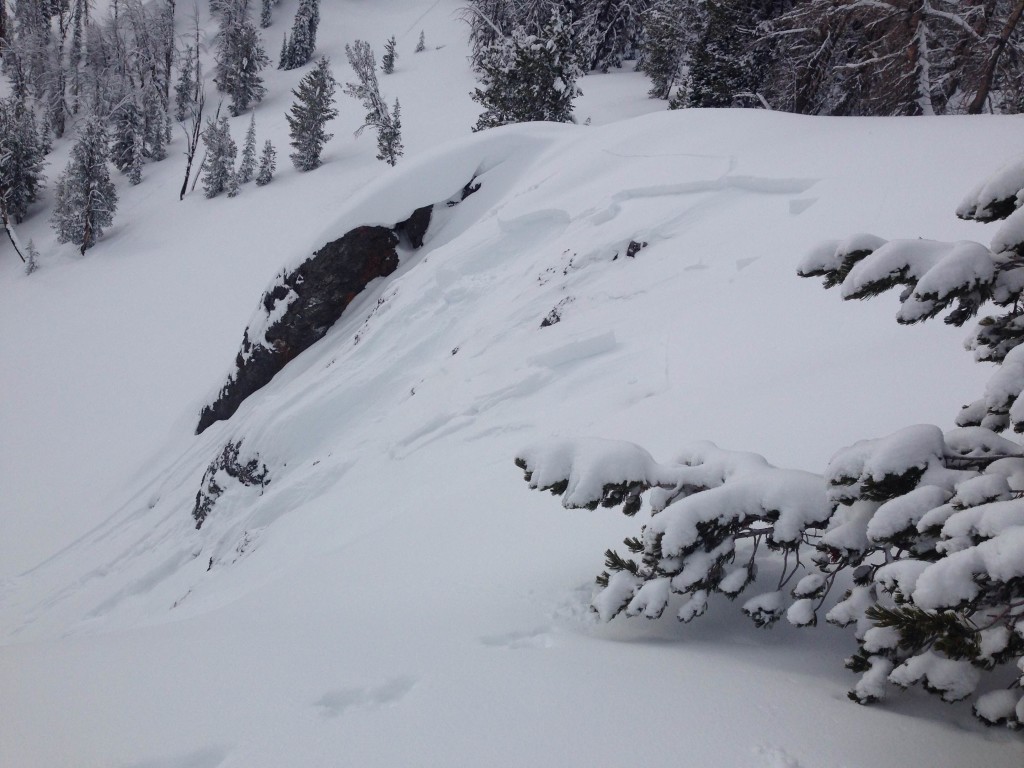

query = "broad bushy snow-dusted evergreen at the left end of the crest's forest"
[471, 11, 586, 131]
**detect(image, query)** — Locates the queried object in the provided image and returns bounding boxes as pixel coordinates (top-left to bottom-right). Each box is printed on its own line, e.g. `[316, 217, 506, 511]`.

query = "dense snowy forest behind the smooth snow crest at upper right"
[465, 0, 1024, 115]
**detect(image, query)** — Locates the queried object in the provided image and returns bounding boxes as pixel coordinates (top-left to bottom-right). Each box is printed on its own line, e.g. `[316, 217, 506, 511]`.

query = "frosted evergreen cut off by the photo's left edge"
[0, 96, 48, 224]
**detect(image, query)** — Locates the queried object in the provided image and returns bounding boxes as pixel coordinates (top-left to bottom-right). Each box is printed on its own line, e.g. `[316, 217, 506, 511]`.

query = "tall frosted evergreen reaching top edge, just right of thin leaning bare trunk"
[216, 0, 270, 115]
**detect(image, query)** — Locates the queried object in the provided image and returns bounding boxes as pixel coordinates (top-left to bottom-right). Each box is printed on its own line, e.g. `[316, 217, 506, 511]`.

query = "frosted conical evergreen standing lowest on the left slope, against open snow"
[51, 117, 118, 255]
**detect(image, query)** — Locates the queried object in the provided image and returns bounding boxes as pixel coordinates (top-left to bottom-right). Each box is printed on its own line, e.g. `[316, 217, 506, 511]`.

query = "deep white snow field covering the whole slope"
[6, 0, 1024, 768]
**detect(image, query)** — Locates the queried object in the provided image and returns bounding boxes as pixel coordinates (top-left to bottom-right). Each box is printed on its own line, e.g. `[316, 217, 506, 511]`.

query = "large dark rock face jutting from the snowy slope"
[196, 225, 401, 434]
